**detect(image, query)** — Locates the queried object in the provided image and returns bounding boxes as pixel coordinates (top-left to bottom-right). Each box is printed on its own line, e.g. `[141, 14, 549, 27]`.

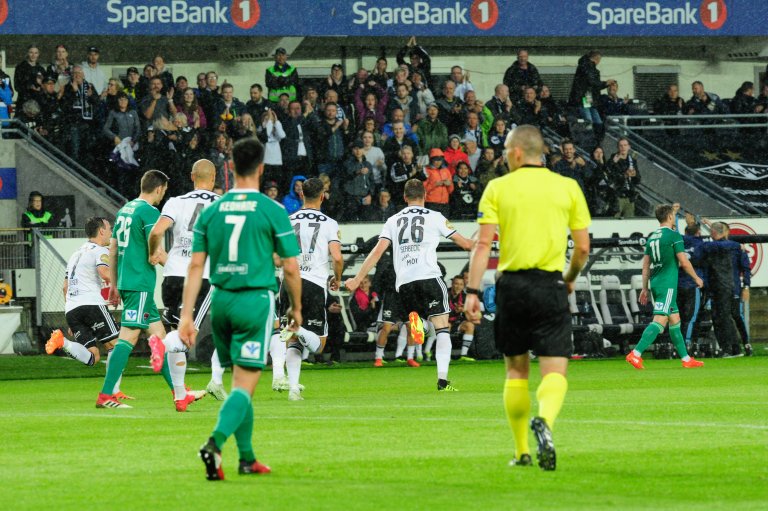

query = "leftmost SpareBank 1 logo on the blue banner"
[106, 0, 261, 30]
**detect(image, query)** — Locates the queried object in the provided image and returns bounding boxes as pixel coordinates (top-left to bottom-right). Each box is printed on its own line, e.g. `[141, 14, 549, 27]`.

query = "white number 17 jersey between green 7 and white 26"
[290, 209, 341, 289]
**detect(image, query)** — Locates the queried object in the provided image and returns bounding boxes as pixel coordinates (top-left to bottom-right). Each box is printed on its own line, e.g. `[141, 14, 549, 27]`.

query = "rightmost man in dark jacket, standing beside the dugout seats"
[692, 222, 741, 355]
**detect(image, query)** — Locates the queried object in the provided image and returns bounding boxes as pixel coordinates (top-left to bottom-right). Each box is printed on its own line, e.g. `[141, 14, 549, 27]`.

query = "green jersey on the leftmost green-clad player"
[112, 199, 160, 293]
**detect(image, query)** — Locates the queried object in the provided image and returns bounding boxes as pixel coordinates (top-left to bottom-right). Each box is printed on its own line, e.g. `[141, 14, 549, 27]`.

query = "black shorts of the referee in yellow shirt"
[493, 270, 573, 357]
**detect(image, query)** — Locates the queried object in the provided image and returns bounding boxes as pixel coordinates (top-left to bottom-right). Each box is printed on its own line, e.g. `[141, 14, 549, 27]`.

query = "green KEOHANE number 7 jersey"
[192, 189, 300, 291]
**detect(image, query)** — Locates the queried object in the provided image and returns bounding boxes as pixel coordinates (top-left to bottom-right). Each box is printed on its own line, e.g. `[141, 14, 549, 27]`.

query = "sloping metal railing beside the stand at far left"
[0, 119, 128, 207]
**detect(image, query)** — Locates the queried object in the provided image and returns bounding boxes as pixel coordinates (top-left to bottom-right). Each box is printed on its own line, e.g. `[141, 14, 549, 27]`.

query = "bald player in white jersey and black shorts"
[149, 160, 219, 408]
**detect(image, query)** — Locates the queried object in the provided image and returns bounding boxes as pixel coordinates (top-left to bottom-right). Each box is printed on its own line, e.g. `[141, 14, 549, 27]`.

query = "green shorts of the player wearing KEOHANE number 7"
[211, 288, 275, 369]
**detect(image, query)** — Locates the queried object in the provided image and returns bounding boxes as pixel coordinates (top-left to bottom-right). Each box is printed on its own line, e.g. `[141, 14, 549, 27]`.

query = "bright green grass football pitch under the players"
[0, 356, 768, 511]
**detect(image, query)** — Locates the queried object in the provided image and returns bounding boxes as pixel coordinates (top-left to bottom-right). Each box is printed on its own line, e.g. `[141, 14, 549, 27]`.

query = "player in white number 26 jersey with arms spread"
[345, 179, 473, 391]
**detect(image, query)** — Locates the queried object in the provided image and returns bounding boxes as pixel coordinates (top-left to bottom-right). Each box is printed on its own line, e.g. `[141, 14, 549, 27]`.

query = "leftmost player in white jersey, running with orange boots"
[45, 217, 128, 399]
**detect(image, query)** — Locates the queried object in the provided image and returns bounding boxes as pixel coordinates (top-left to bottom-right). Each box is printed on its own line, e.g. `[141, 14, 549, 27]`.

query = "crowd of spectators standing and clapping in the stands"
[0, 41, 768, 221]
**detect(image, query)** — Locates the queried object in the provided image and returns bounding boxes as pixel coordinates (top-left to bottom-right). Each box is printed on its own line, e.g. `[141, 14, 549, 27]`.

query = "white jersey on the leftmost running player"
[64, 241, 109, 312]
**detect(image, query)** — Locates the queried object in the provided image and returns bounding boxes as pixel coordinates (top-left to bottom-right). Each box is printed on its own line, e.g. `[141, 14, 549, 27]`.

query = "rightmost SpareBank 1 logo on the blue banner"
[587, 0, 728, 30]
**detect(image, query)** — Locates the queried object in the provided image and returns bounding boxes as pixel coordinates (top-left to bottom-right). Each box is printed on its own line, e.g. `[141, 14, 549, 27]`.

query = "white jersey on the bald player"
[160, 190, 219, 279]
